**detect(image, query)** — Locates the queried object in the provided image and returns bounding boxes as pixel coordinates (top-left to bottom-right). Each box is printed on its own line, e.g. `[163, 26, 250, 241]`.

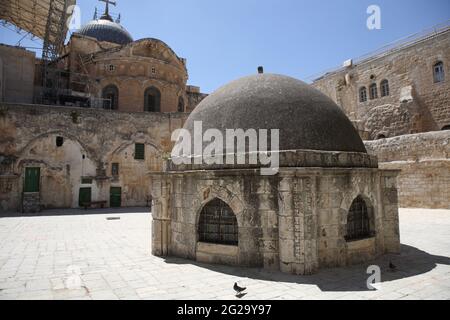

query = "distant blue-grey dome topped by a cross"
[77, 19, 133, 45]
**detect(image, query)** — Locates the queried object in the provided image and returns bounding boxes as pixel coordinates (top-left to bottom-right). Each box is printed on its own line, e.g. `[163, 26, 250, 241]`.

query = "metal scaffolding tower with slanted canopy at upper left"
[0, 0, 76, 104]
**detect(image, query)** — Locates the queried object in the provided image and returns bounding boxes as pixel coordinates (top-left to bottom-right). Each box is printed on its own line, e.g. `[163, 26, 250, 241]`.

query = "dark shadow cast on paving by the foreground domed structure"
[165, 245, 450, 292]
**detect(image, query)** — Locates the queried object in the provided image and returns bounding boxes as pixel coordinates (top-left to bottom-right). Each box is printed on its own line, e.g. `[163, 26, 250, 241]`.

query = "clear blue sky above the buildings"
[0, 0, 450, 93]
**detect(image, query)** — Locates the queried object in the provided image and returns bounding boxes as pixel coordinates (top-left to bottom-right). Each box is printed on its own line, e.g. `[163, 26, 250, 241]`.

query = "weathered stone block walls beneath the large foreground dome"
[152, 168, 400, 275]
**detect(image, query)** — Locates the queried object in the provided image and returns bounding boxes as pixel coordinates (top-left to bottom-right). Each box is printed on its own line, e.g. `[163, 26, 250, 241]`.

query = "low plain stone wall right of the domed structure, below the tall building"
[365, 131, 450, 209]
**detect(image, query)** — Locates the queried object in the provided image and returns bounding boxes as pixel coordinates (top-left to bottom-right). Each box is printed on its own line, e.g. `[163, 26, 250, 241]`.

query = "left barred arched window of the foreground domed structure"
[198, 199, 238, 246]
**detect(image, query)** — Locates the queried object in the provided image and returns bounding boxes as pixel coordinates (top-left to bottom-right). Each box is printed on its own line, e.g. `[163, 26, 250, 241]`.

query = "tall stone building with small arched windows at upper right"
[313, 26, 450, 140]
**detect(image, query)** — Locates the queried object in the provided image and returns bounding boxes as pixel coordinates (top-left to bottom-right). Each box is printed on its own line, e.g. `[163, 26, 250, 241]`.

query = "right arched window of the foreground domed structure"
[345, 196, 374, 241]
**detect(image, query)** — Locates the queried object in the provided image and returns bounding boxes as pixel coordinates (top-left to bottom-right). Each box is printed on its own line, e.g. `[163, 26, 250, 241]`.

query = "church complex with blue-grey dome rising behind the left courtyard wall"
[0, 2, 206, 113]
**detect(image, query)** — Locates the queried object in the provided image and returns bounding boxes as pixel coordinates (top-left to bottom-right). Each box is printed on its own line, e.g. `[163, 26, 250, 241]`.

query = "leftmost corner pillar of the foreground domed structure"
[152, 176, 171, 257]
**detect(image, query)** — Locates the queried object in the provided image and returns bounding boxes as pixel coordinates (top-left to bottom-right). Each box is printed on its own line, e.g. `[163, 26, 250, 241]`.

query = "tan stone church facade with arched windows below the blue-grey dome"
[60, 34, 204, 112]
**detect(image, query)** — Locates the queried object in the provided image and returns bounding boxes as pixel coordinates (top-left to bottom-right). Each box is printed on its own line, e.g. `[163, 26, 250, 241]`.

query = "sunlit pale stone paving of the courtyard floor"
[0, 209, 450, 300]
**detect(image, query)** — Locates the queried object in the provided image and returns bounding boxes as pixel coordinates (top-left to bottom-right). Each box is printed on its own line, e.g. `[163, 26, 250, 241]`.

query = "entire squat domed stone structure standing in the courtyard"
[152, 74, 400, 275]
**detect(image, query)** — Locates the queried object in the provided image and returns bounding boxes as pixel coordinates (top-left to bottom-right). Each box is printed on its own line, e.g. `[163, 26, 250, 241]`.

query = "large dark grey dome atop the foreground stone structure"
[184, 74, 367, 153]
